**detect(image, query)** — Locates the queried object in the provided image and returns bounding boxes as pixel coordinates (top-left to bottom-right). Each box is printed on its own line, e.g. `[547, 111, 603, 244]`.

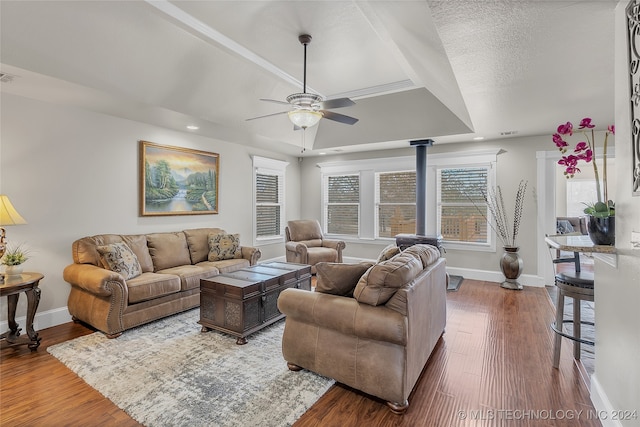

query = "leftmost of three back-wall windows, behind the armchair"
[324, 175, 360, 236]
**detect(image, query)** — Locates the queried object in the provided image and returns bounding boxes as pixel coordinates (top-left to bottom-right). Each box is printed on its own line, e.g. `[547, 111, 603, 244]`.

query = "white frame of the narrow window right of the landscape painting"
[253, 156, 289, 246]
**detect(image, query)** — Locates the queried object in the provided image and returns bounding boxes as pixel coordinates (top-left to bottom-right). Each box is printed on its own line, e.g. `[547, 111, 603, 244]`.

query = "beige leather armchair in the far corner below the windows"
[285, 219, 347, 274]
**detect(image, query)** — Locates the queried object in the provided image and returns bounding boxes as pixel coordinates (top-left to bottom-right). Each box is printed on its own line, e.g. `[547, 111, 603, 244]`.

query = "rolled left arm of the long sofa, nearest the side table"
[62, 264, 128, 301]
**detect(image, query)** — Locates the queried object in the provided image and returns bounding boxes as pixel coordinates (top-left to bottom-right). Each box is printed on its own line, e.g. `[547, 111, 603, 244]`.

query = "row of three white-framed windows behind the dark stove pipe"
[318, 149, 499, 251]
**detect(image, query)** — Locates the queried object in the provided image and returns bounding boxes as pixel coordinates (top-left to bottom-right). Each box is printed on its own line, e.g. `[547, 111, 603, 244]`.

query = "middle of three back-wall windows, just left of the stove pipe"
[376, 171, 416, 238]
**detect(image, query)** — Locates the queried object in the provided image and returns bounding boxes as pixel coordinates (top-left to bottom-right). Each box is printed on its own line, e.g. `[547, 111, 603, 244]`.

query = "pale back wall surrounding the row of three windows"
[301, 137, 554, 286]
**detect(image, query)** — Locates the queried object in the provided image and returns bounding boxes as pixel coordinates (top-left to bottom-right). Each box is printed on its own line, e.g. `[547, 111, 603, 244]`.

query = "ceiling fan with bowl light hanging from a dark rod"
[247, 34, 358, 130]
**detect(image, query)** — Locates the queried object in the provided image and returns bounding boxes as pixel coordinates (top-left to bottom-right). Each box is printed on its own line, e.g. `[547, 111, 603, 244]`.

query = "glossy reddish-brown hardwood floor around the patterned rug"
[0, 280, 601, 427]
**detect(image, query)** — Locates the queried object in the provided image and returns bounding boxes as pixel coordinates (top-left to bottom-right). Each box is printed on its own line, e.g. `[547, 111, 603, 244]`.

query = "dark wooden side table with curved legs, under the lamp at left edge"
[0, 273, 44, 351]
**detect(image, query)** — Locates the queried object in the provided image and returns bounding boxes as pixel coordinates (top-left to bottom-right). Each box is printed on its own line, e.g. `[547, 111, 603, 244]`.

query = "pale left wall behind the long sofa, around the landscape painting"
[0, 94, 300, 329]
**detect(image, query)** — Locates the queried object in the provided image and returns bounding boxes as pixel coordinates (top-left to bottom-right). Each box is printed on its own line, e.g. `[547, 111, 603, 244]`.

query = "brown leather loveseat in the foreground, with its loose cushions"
[278, 245, 447, 414]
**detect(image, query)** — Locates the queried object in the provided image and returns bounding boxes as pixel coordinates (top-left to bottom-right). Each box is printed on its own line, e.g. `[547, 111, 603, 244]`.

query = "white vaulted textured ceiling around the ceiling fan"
[0, 0, 616, 155]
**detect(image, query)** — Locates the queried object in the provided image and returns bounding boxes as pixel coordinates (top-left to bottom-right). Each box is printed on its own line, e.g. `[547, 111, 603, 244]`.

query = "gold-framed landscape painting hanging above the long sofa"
[140, 141, 220, 216]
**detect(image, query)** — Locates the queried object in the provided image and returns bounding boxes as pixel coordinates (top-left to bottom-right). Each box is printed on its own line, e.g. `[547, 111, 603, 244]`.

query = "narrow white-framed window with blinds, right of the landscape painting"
[253, 156, 288, 243]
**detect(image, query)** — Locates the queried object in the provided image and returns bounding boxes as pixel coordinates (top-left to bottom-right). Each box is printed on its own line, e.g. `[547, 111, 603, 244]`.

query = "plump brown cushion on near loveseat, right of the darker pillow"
[353, 252, 423, 306]
